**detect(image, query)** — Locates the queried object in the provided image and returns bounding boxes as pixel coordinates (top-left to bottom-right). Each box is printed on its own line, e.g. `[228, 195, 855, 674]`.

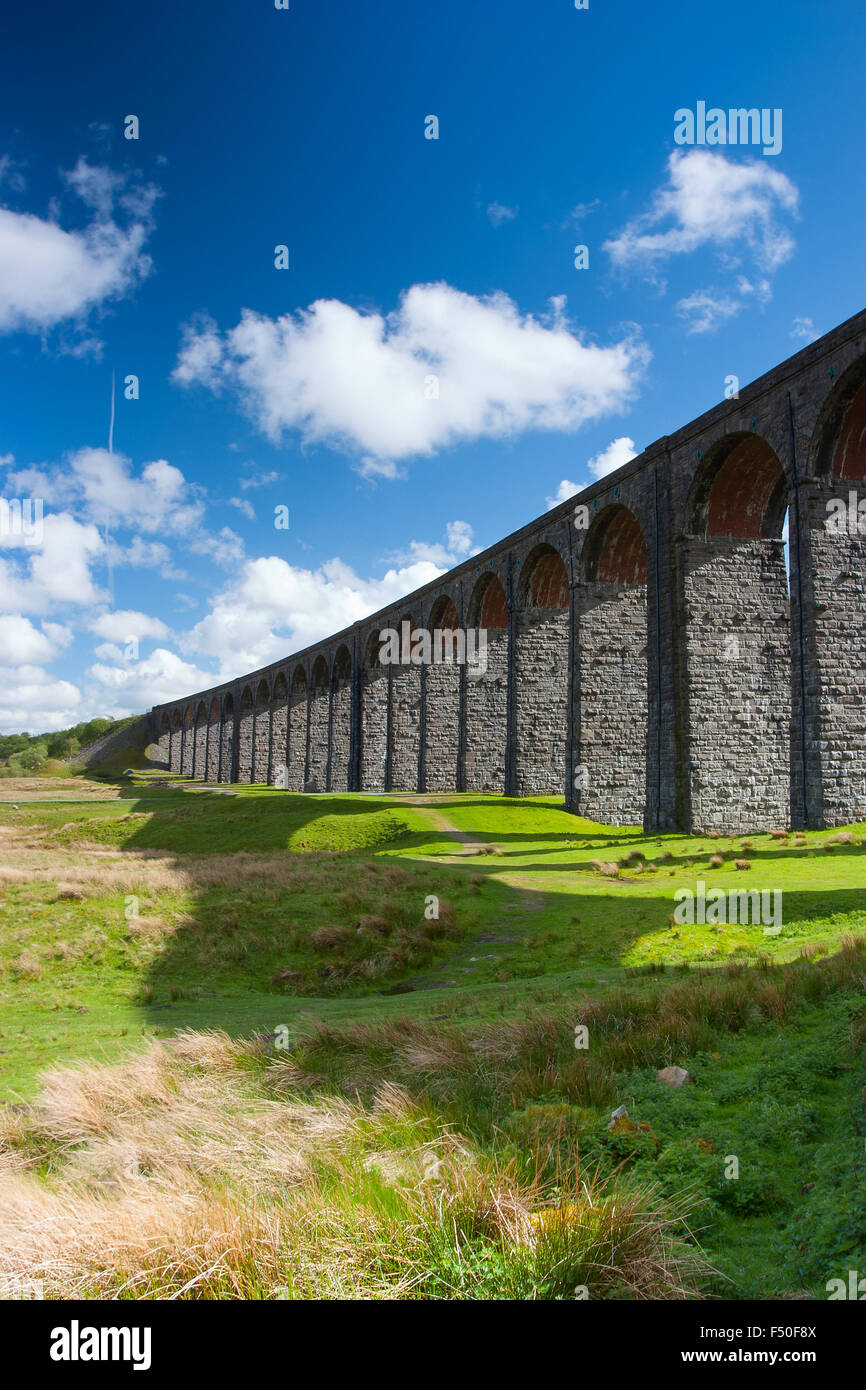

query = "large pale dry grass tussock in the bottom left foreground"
[0, 1029, 703, 1298]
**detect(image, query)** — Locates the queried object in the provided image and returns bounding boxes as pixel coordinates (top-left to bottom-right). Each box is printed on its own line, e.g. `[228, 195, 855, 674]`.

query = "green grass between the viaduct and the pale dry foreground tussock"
[0, 777, 866, 1298]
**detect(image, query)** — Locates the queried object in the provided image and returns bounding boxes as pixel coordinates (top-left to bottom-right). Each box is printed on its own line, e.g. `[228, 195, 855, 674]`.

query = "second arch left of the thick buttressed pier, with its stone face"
[509, 541, 570, 796]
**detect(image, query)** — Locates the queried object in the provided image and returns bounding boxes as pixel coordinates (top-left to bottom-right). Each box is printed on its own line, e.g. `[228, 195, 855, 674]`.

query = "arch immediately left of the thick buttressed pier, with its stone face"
[569, 503, 646, 826]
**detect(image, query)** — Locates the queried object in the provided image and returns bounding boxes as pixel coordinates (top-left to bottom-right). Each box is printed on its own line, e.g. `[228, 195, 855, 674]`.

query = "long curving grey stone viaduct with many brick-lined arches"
[150, 310, 866, 833]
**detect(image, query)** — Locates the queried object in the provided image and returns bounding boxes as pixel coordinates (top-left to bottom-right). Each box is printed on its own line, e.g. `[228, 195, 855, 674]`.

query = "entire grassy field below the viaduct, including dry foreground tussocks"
[0, 776, 866, 1298]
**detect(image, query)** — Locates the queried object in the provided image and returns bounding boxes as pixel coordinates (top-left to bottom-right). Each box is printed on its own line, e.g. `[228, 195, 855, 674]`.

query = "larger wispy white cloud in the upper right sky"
[605, 150, 798, 274]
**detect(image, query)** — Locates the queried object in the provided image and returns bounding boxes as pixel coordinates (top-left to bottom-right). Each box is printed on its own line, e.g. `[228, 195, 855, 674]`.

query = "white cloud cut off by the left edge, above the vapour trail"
[0, 158, 157, 332]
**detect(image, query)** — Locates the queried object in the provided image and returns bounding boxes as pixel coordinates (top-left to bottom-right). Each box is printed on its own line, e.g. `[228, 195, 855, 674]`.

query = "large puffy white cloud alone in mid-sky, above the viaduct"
[174, 284, 649, 477]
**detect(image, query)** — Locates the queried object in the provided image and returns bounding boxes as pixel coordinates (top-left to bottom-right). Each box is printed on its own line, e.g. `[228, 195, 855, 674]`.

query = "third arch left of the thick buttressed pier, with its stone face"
[463, 570, 509, 792]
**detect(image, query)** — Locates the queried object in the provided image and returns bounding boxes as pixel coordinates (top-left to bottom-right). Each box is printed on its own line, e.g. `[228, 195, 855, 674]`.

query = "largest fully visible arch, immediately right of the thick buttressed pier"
[678, 434, 792, 831]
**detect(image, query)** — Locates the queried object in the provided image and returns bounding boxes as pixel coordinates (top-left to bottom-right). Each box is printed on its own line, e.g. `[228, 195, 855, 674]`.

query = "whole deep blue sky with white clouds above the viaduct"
[0, 0, 866, 731]
